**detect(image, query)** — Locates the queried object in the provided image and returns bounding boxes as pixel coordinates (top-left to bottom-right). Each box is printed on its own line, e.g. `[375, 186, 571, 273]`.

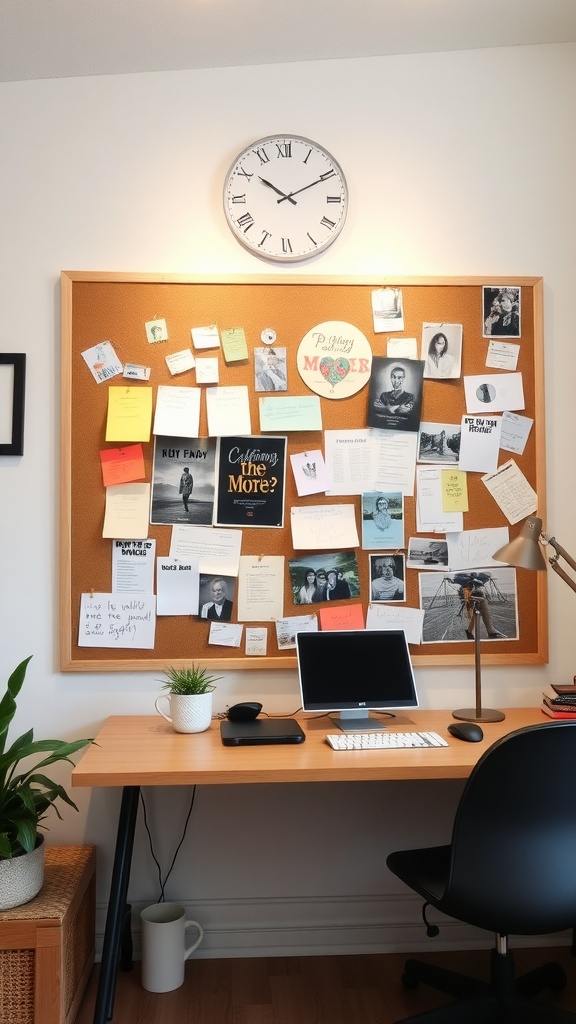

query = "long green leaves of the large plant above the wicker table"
[0, 655, 92, 860]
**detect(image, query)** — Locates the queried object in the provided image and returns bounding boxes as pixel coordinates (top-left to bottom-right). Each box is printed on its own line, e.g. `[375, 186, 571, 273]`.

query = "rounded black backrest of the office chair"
[445, 720, 576, 935]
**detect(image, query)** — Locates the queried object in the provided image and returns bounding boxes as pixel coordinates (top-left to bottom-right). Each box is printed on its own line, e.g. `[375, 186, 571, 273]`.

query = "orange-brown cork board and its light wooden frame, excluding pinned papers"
[59, 271, 547, 672]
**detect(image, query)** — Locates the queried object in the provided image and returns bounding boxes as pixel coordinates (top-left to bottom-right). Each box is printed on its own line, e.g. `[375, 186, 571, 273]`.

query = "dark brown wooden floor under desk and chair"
[76, 947, 576, 1024]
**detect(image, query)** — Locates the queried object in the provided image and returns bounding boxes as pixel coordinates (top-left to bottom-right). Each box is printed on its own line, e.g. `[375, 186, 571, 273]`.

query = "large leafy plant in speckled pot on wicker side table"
[0, 655, 92, 910]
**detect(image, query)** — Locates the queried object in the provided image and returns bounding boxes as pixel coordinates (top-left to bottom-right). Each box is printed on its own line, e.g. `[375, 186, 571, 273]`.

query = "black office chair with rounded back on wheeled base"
[386, 721, 576, 1024]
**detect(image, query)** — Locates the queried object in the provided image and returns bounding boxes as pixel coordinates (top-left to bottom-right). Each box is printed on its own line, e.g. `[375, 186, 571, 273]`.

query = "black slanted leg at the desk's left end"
[94, 785, 140, 1024]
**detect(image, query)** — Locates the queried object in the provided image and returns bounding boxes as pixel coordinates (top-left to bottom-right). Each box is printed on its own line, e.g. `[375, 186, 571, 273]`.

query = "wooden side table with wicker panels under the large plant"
[0, 846, 96, 1024]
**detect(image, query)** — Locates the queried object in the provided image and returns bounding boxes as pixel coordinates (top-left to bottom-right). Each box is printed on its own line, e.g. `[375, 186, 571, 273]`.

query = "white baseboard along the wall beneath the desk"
[96, 895, 572, 959]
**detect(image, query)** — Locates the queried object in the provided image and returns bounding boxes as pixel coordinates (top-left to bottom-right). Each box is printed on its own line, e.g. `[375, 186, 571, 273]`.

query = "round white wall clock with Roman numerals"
[223, 135, 347, 263]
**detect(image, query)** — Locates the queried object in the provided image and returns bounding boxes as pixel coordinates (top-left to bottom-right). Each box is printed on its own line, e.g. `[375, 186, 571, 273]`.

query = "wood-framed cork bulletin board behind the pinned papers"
[60, 271, 547, 672]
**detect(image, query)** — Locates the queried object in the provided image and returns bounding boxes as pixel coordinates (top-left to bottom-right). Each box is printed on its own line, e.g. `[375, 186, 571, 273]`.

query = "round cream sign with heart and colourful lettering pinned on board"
[296, 321, 372, 398]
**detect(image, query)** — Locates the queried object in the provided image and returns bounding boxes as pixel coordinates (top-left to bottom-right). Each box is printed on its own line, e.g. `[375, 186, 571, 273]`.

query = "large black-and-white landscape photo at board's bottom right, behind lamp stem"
[418, 566, 518, 643]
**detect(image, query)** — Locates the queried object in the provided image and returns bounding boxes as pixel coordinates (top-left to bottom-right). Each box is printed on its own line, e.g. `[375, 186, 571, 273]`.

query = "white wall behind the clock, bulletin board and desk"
[0, 37, 576, 954]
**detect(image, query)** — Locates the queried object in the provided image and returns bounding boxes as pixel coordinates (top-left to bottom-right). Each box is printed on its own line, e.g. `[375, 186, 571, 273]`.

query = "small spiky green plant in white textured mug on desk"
[156, 665, 221, 732]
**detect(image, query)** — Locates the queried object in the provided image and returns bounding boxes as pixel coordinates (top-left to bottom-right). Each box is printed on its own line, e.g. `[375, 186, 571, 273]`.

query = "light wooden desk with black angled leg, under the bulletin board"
[72, 708, 547, 1024]
